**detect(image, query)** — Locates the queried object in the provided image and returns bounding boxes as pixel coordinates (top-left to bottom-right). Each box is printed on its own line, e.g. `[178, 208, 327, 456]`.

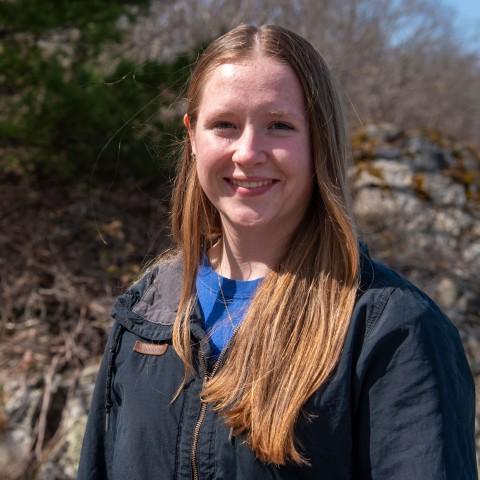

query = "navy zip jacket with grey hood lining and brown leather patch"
[78, 249, 477, 480]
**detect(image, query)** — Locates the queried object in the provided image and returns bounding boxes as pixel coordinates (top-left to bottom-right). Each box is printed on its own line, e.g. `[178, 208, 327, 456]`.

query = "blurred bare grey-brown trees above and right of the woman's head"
[120, 0, 480, 145]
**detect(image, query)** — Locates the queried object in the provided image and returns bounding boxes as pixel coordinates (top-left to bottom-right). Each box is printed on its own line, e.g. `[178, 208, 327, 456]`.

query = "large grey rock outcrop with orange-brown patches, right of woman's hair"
[350, 126, 480, 332]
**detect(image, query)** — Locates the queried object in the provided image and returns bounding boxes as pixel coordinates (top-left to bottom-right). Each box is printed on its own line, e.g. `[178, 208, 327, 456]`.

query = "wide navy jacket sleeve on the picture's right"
[355, 288, 477, 480]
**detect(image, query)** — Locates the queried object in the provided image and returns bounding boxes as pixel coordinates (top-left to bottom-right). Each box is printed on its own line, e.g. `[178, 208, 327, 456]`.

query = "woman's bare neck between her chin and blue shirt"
[208, 225, 287, 280]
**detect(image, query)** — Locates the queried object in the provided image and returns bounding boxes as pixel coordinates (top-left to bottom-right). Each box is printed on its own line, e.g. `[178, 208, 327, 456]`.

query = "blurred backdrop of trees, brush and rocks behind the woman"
[0, 0, 480, 479]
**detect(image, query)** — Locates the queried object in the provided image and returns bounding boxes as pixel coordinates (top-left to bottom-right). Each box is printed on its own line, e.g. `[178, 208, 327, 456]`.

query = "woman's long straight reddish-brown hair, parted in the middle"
[172, 25, 359, 465]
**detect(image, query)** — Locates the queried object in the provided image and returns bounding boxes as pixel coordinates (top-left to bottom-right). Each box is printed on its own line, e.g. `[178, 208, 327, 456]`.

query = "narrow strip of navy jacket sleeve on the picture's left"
[77, 325, 121, 480]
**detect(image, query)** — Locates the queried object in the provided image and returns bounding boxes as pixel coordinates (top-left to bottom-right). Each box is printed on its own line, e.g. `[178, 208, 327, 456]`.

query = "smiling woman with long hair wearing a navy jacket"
[79, 25, 476, 480]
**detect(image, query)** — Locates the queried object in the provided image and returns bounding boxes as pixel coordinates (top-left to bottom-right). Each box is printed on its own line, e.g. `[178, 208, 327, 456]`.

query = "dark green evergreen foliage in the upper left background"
[0, 0, 199, 180]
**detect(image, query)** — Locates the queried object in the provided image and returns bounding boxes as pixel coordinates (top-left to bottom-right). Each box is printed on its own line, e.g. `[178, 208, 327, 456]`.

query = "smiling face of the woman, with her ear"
[185, 55, 313, 234]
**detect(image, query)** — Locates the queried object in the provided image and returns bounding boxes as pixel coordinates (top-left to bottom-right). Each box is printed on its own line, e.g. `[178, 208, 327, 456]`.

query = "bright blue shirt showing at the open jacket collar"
[196, 259, 262, 357]
